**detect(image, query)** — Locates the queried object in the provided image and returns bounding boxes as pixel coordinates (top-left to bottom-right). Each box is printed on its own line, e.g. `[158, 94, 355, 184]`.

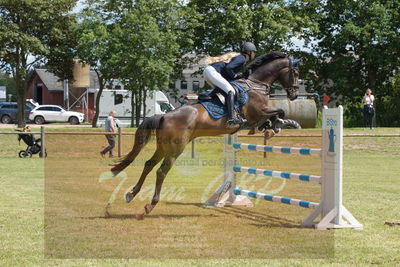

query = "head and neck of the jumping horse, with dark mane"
[248, 51, 301, 100]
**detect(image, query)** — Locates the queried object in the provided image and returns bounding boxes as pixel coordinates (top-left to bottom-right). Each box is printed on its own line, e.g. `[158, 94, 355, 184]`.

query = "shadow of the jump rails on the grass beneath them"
[166, 202, 302, 228]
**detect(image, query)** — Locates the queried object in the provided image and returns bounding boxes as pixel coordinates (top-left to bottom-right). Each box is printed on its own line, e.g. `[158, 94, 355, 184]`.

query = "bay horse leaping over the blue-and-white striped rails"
[106, 52, 300, 218]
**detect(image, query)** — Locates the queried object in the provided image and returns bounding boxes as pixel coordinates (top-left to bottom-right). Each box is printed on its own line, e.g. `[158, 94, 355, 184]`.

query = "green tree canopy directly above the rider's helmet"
[189, 0, 315, 55]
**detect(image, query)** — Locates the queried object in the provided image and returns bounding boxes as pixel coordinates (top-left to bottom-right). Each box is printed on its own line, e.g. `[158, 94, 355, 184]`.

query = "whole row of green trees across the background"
[0, 0, 400, 126]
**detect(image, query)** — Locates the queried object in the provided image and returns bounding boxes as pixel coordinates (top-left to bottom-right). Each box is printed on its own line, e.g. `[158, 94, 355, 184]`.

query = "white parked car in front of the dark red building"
[29, 105, 85, 124]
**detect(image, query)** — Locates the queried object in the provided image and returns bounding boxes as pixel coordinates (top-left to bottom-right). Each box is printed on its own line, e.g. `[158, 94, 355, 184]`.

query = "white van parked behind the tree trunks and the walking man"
[97, 89, 175, 127]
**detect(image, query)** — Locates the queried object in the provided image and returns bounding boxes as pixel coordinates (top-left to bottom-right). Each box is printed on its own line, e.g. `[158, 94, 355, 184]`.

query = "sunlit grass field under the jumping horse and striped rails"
[0, 129, 400, 266]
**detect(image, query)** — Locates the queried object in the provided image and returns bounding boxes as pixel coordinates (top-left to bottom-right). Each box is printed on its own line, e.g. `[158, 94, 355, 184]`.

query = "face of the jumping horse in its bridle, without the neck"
[277, 58, 301, 100]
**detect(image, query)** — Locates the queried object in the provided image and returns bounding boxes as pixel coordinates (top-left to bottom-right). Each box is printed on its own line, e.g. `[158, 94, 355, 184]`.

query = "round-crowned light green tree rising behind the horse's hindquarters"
[78, 0, 191, 124]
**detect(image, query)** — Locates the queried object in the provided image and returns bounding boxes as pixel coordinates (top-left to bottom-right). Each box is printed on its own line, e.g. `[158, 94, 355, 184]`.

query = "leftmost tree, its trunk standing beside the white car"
[0, 0, 76, 127]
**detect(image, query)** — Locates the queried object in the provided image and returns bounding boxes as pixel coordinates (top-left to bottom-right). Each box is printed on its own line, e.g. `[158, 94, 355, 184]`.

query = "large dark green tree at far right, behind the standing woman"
[304, 0, 400, 126]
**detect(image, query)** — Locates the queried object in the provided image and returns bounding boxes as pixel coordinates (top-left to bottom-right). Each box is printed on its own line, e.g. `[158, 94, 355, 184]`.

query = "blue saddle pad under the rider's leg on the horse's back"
[200, 81, 249, 119]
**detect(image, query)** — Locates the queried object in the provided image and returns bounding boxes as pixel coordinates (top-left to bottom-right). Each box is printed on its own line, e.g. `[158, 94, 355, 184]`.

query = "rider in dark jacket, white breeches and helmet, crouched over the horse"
[204, 42, 257, 125]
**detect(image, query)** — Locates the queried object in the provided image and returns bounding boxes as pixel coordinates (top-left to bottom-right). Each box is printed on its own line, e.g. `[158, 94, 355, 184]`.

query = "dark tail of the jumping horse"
[111, 115, 163, 175]
